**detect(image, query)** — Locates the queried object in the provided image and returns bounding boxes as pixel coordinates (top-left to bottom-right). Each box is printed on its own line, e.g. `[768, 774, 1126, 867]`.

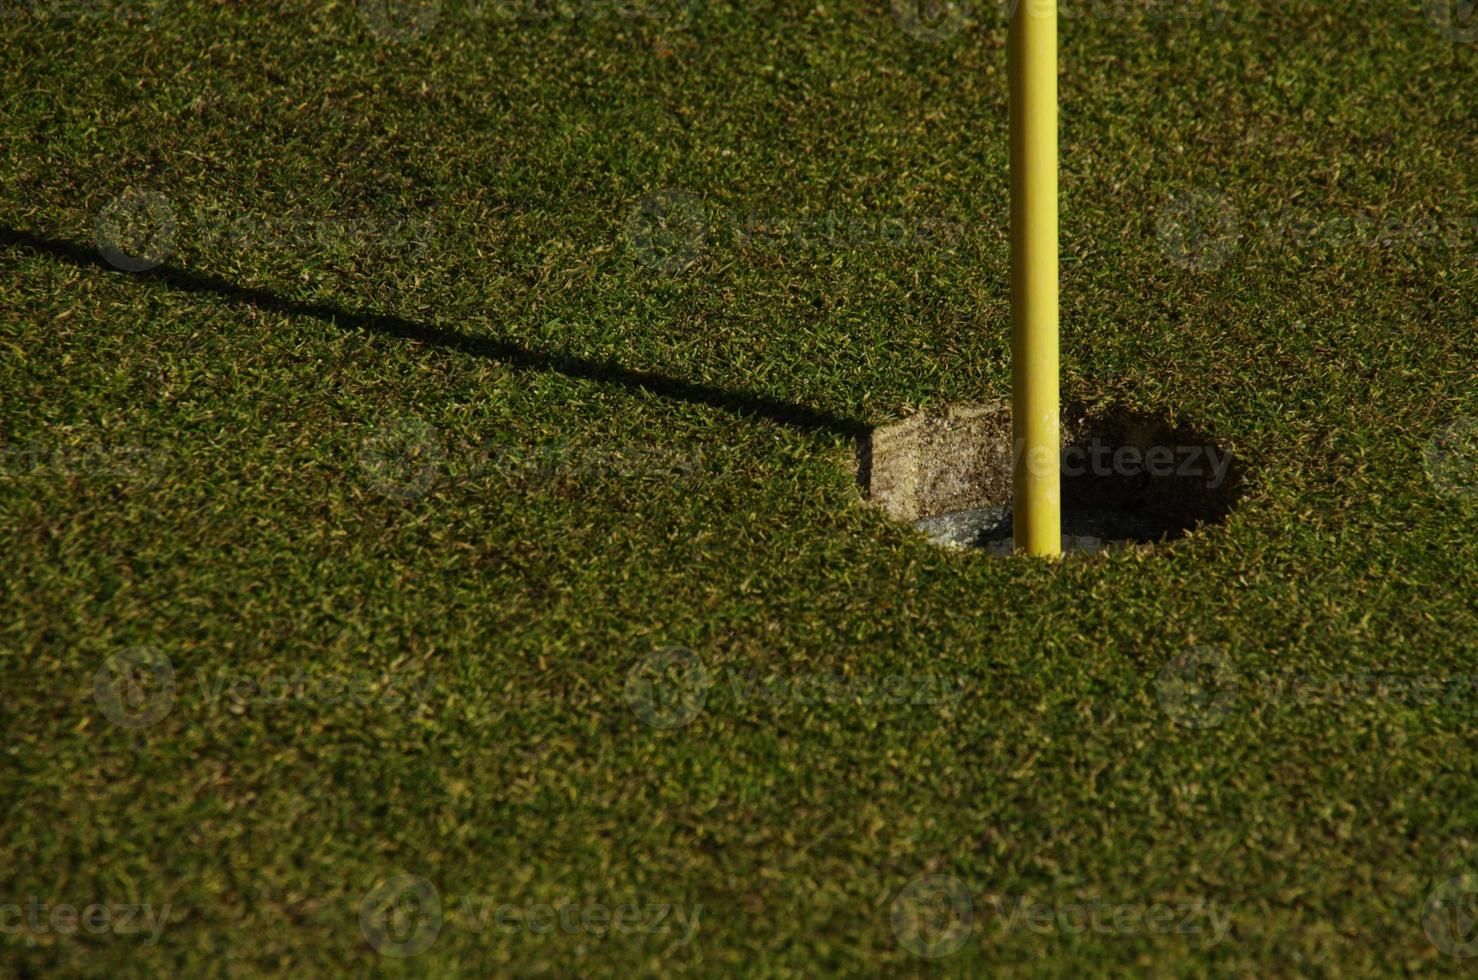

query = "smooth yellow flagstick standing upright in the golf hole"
[1007, 0, 1063, 556]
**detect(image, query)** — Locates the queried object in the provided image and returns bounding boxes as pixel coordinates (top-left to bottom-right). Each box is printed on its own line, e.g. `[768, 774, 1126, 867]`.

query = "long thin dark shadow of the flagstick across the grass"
[0, 228, 871, 439]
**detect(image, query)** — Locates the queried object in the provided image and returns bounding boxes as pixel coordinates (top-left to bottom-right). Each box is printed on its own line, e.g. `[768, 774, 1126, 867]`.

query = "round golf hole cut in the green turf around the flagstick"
[857, 405, 1244, 554]
